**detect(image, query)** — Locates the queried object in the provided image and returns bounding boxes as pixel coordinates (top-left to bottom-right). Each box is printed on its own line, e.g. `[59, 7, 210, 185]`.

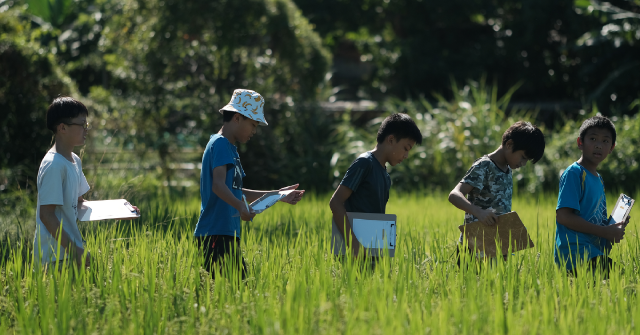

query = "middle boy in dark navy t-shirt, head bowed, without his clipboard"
[329, 114, 422, 256]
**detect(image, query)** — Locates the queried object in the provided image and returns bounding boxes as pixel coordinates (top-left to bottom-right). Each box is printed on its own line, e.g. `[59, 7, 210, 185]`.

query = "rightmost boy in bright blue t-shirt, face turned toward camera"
[554, 116, 629, 274]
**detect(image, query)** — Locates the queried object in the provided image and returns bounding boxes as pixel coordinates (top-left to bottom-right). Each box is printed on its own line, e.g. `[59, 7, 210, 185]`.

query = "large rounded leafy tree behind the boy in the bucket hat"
[90, 0, 330, 189]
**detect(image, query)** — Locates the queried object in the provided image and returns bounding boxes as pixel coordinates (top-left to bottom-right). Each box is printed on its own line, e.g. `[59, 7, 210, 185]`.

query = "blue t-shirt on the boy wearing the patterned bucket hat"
[193, 134, 245, 238]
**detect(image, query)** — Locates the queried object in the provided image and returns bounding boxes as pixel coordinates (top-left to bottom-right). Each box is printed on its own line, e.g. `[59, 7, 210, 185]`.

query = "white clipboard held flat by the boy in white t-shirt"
[78, 199, 140, 221]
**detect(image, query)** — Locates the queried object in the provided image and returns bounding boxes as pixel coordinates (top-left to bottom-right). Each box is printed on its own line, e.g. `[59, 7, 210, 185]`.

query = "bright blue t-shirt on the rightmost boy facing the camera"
[554, 163, 611, 270]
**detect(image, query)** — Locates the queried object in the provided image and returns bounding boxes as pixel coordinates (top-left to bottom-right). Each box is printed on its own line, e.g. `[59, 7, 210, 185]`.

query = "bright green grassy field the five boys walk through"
[0, 193, 640, 334]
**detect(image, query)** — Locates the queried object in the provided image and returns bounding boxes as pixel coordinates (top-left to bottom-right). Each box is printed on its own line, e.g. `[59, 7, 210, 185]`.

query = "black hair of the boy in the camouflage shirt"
[502, 121, 545, 164]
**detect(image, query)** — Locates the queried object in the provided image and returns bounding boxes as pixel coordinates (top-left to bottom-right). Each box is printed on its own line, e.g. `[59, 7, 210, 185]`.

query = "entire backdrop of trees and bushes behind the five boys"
[0, 0, 640, 192]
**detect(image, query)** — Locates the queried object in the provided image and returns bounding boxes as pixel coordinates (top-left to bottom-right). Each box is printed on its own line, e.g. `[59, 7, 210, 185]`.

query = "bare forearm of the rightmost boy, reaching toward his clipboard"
[556, 207, 629, 243]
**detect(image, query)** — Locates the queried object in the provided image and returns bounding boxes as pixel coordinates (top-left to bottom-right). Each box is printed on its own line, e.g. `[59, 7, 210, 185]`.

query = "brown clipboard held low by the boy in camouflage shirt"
[458, 212, 534, 257]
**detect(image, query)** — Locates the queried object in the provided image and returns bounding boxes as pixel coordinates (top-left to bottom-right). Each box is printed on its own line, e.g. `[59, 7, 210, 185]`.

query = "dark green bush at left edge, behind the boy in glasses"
[0, 6, 75, 182]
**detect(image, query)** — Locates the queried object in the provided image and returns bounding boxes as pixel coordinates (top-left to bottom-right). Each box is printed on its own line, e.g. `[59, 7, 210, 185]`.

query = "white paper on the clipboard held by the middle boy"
[353, 219, 396, 249]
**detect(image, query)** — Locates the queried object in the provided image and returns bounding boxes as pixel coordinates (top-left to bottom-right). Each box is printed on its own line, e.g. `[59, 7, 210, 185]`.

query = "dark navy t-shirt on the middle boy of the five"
[340, 152, 391, 214]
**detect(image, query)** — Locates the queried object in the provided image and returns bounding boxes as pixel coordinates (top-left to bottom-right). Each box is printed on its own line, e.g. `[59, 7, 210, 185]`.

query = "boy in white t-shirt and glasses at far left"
[33, 97, 137, 267]
